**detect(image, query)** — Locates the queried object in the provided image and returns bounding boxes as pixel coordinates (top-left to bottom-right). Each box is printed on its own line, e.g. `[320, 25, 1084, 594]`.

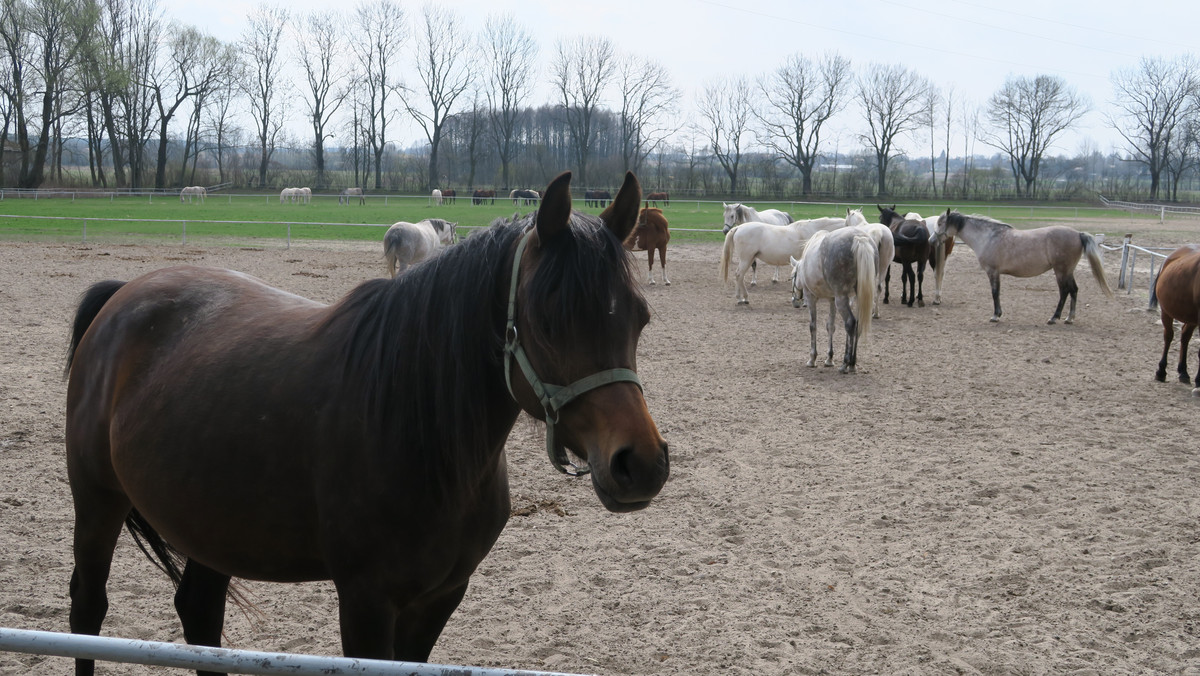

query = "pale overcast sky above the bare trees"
[162, 0, 1200, 155]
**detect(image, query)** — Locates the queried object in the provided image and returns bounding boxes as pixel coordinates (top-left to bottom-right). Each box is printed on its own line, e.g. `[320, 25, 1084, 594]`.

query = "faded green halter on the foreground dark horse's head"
[504, 228, 642, 477]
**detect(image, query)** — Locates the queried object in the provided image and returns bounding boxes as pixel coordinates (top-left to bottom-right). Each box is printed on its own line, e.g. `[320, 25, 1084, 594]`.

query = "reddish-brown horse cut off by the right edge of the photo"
[1150, 244, 1200, 396]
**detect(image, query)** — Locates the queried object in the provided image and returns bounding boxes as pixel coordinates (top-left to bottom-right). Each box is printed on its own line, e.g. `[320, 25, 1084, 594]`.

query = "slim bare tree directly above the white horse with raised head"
[696, 77, 754, 195]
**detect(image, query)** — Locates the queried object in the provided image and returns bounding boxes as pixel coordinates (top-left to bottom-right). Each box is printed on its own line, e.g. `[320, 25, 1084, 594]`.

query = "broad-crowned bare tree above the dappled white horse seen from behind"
[756, 54, 851, 195]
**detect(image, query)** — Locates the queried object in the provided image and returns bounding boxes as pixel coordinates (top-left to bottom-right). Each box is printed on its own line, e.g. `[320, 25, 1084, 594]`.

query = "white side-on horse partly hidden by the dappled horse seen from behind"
[721, 214, 862, 305]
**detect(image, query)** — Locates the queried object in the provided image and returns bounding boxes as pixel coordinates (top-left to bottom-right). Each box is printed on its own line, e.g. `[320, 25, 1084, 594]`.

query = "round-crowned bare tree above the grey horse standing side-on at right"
[980, 76, 1090, 197]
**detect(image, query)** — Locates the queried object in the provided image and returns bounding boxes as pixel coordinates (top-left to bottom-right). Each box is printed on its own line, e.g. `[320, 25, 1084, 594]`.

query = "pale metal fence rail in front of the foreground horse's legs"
[0, 628, 592, 676]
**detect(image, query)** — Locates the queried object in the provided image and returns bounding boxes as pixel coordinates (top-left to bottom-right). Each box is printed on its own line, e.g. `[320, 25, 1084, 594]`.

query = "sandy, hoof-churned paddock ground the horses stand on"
[0, 222, 1200, 675]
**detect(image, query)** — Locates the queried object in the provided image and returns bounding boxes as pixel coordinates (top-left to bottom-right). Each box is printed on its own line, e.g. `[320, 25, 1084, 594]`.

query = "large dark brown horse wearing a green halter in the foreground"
[66, 173, 668, 674]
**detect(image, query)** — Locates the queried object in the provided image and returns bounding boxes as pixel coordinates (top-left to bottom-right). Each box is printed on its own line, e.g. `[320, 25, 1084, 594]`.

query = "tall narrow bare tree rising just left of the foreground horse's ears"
[480, 14, 538, 189]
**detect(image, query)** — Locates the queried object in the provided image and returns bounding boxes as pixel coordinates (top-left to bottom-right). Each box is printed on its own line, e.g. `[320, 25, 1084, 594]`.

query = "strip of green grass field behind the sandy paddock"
[0, 193, 1147, 241]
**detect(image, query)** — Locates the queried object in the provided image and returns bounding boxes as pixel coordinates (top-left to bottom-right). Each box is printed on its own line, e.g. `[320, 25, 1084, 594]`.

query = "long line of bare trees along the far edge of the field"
[0, 0, 1200, 198]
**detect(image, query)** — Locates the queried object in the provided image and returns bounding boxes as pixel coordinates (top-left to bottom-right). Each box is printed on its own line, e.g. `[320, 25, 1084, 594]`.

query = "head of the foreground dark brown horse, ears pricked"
[505, 172, 670, 512]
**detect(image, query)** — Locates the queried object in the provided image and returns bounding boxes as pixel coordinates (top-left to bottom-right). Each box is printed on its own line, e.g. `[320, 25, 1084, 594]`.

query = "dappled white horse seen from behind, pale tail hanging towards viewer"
[790, 227, 880, 373]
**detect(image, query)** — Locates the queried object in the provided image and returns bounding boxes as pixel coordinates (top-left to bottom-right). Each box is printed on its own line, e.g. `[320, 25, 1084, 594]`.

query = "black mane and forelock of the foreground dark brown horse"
[316, 213, 647, 490]
